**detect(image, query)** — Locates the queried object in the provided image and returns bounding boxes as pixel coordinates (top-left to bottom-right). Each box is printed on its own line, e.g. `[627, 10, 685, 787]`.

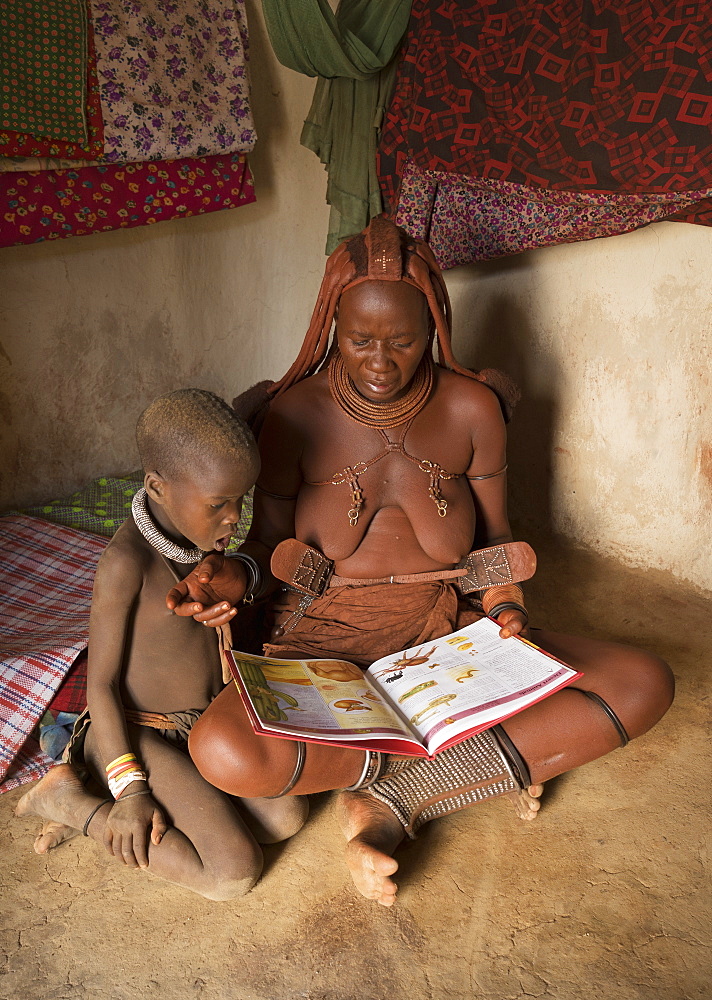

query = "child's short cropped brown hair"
[136, 389, 258, 479]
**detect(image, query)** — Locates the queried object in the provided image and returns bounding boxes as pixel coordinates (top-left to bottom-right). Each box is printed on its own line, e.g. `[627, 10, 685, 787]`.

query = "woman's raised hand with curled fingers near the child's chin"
[166, 552, 248, 628]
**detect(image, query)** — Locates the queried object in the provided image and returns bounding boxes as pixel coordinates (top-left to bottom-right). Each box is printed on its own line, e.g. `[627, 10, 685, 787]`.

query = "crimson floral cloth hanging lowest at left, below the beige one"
[0, 153, 255, 246]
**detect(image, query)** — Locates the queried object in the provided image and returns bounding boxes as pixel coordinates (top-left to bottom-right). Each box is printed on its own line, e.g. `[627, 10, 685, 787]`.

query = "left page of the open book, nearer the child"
[229, 650, 413, 739]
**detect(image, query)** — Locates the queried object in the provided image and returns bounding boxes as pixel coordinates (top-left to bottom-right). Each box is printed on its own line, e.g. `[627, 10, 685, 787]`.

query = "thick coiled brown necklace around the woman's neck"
[329, 351, 433, 427]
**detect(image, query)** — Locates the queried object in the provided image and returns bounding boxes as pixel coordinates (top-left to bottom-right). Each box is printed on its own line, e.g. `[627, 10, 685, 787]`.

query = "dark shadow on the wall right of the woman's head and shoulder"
[454, 257, 561, 534]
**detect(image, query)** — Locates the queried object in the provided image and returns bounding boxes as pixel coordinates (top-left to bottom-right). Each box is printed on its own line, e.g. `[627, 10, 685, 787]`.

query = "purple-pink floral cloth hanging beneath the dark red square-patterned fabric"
[395, 163, 712, 269]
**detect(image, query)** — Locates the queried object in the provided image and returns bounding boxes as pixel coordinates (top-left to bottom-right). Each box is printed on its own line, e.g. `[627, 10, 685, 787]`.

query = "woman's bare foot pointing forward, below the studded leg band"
[337, 792, 403, 906]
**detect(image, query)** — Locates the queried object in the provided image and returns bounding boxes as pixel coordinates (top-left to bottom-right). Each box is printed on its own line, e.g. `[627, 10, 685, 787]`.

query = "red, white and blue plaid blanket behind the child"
[0, 514, 106, 791]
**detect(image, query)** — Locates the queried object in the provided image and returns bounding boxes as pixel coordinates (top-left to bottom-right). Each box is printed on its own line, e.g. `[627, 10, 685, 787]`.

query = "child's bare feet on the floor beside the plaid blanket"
[15, 764, 101, 854]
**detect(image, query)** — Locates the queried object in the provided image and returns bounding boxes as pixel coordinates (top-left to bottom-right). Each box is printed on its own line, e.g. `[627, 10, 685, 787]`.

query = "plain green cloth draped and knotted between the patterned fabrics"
[262, 0, 412, 253]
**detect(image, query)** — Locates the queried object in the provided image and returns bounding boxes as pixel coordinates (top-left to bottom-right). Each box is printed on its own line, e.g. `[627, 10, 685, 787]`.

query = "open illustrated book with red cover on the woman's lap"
[225, 618, 583, 757]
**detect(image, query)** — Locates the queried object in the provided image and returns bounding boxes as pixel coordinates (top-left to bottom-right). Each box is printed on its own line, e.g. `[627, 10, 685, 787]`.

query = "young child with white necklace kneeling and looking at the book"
[16, 389, 307, 900]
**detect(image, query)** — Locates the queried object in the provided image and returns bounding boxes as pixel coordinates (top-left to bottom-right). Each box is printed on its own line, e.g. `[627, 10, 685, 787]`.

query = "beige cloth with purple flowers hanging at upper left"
[92, 0, 256, 163]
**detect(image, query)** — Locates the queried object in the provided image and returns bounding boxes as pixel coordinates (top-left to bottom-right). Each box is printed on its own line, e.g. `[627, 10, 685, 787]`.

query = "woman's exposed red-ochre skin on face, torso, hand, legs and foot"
[169, 280, 673, 905]
